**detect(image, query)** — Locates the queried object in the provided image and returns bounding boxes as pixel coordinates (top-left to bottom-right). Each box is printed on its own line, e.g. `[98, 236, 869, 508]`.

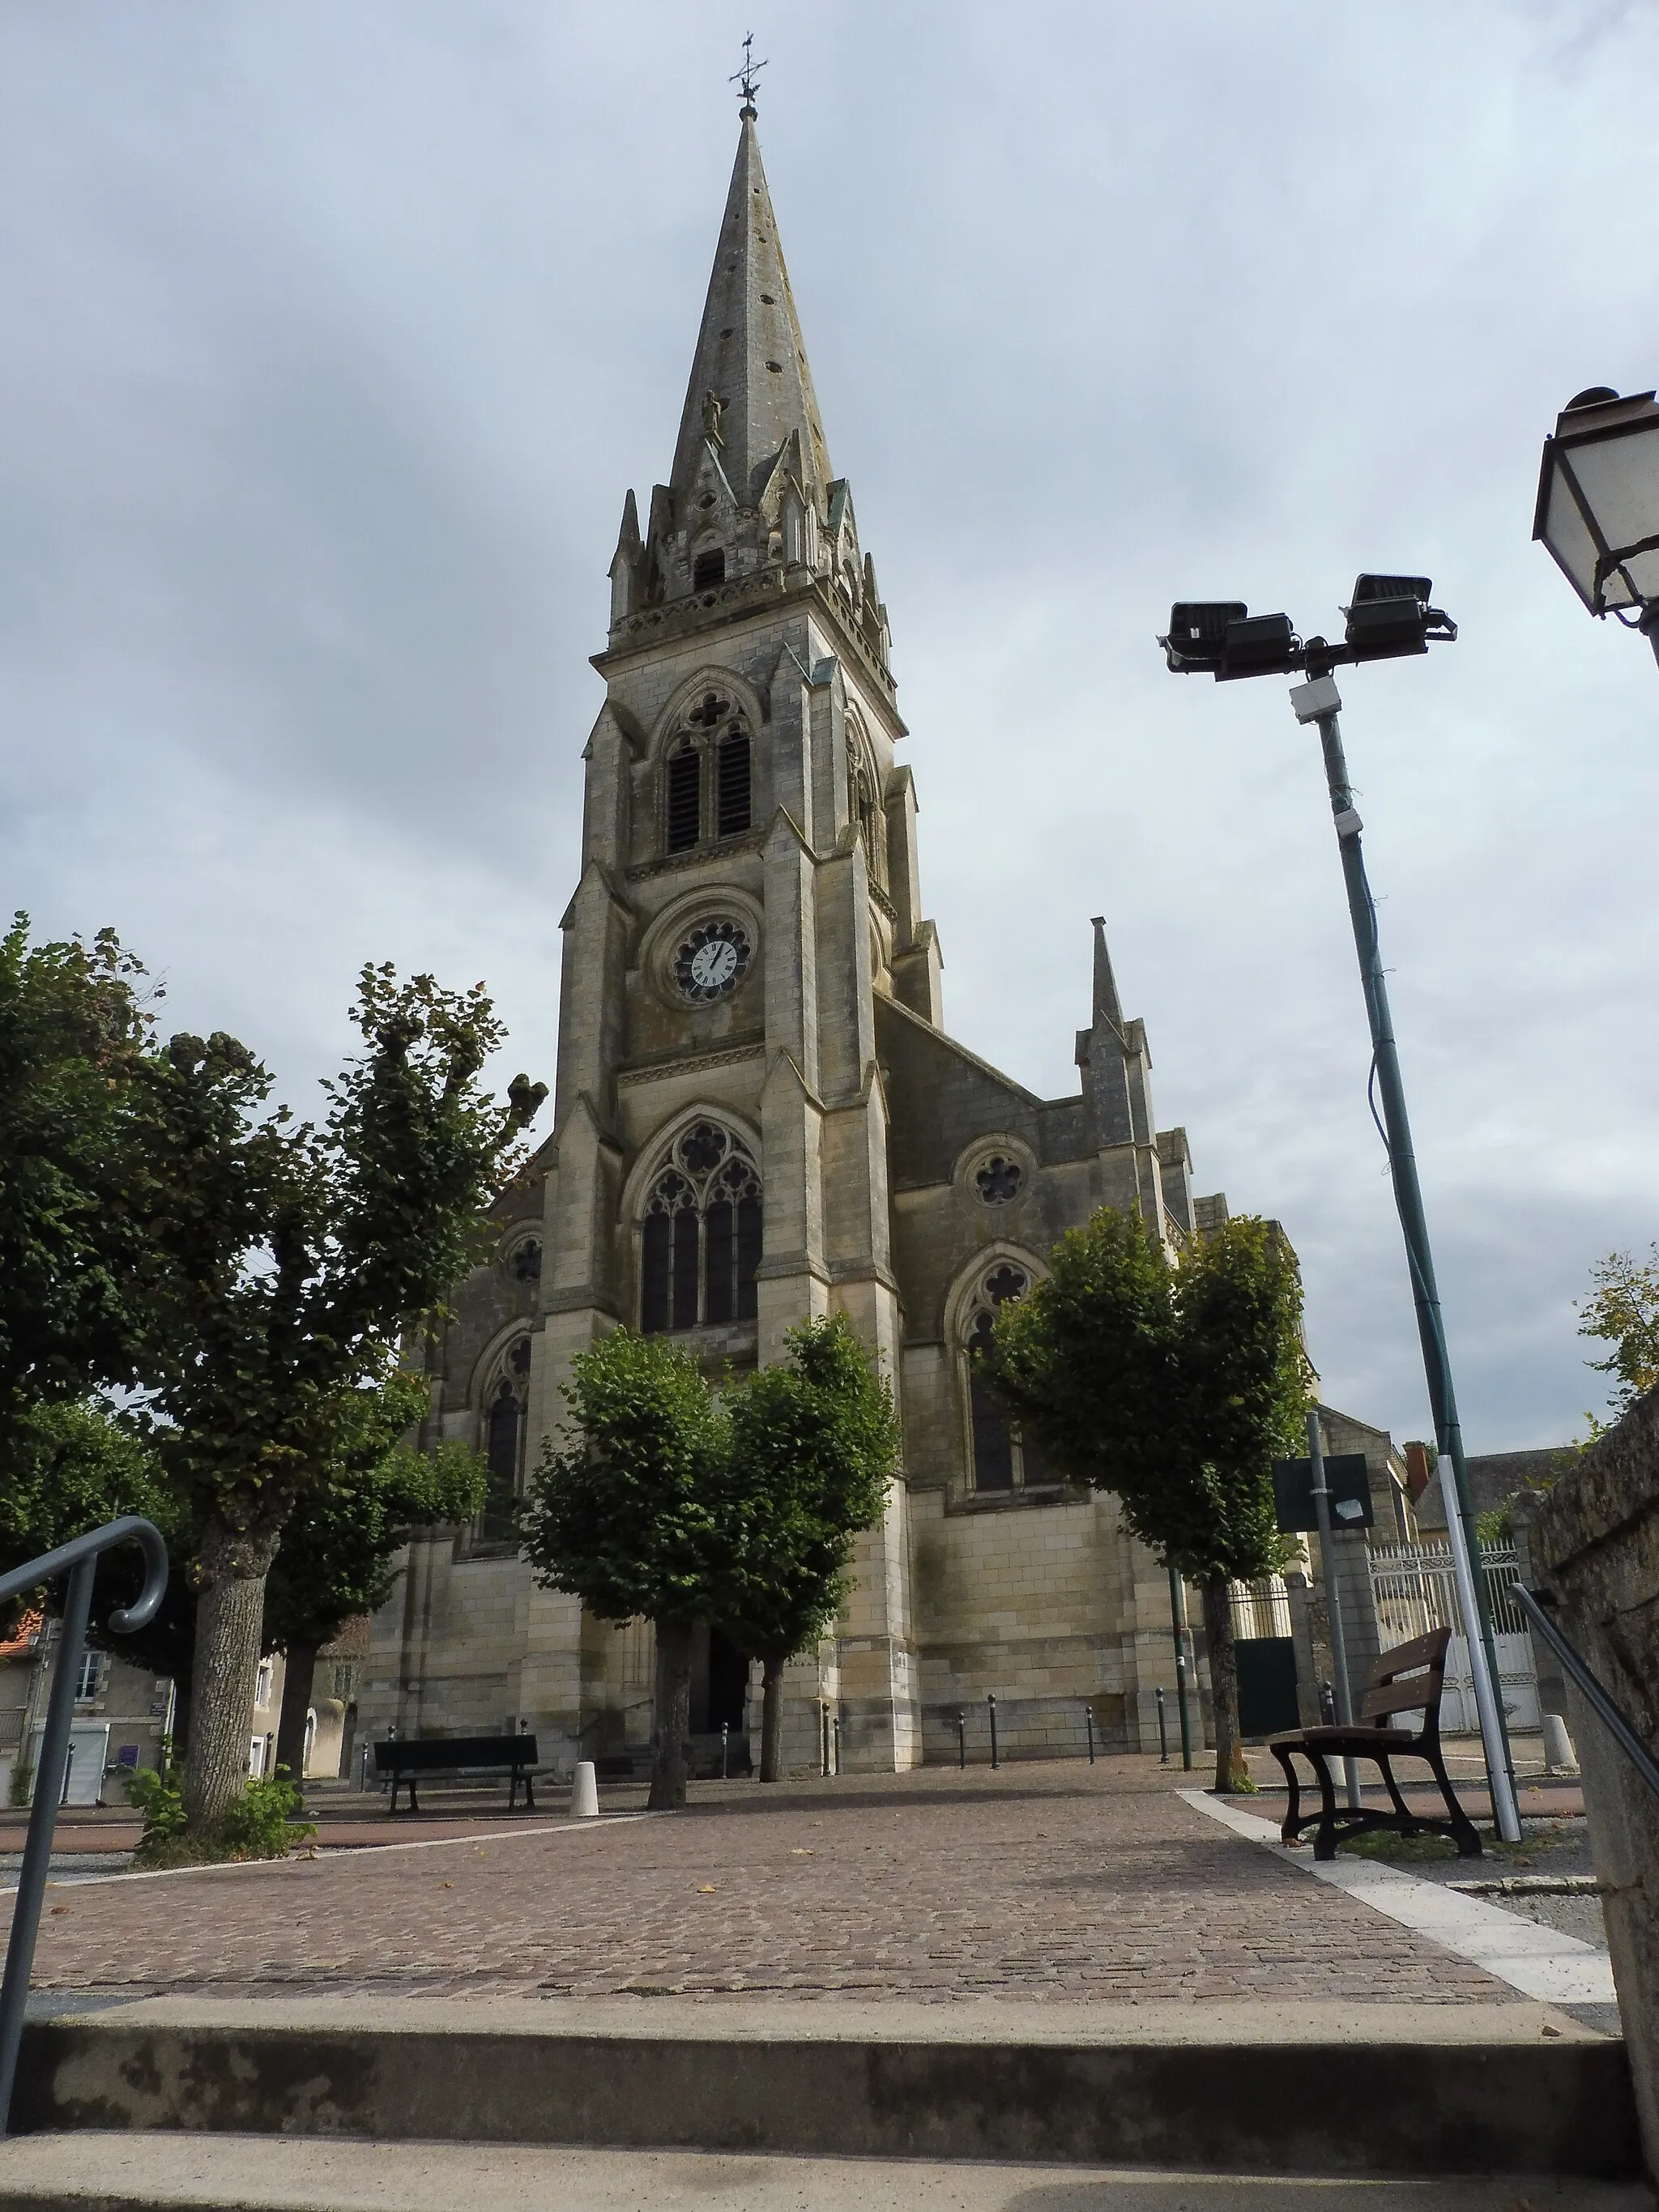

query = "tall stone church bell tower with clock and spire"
[535, 100, 940, 1770]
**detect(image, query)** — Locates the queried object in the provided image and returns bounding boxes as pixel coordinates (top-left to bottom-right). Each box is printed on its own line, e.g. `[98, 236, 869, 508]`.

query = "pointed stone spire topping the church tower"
[668, 114, 832, 506]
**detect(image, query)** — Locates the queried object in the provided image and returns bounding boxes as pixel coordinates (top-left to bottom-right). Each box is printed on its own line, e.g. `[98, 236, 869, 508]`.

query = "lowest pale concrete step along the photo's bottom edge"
[0, 2134, 1655, 2212]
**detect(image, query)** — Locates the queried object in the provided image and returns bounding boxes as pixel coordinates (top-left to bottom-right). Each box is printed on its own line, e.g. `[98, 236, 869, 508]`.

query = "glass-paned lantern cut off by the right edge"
[1533, 385, 1659, 659]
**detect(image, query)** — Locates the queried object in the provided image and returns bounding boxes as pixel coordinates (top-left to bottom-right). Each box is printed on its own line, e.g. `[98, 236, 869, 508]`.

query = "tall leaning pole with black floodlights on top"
[1159, 575, 1520, 1843]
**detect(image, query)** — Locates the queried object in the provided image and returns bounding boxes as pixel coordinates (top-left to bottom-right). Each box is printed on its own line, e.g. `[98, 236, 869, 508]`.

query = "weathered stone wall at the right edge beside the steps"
[1529, 1392, 1659, 2172]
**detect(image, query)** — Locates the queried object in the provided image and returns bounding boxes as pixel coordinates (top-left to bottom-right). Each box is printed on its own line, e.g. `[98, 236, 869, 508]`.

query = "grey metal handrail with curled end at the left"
[0, 1513, 168, 2134]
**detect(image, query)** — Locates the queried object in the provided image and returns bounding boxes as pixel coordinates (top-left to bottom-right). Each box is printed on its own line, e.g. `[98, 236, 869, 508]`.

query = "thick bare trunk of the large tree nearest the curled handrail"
[184, 1515, 281, 1836]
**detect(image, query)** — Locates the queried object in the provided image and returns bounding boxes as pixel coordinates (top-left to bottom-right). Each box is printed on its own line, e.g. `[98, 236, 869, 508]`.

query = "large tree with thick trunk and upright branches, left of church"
[143, 966, 544, 1836]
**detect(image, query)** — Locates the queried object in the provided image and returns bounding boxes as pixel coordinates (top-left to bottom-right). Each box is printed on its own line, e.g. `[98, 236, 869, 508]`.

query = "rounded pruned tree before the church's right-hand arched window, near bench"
[989, 1208, 1311, 1789]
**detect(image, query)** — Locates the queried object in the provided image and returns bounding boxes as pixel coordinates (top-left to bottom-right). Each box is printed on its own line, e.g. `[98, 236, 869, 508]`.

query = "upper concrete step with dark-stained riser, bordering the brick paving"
[13, 1997, 1641, 2185]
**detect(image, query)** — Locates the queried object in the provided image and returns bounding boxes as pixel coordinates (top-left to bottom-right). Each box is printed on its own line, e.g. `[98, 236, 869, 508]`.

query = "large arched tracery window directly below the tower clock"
[639, 1122, 761, 1336]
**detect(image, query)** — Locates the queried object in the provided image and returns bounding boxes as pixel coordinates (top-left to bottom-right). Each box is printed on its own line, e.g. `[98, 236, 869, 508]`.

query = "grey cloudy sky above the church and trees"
[0, 0, 1659, 1449]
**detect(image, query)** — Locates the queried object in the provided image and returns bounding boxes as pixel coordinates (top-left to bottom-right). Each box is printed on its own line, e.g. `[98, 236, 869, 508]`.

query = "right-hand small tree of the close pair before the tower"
[717, 1314, 900, 1783]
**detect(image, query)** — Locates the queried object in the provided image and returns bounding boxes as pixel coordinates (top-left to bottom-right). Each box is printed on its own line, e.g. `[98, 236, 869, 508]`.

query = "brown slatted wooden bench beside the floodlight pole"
[1268, 1628, 1480, 1858]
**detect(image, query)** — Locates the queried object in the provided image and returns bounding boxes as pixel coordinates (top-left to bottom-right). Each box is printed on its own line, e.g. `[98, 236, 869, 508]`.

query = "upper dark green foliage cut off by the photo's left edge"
[0, 914, 148, 1424]
